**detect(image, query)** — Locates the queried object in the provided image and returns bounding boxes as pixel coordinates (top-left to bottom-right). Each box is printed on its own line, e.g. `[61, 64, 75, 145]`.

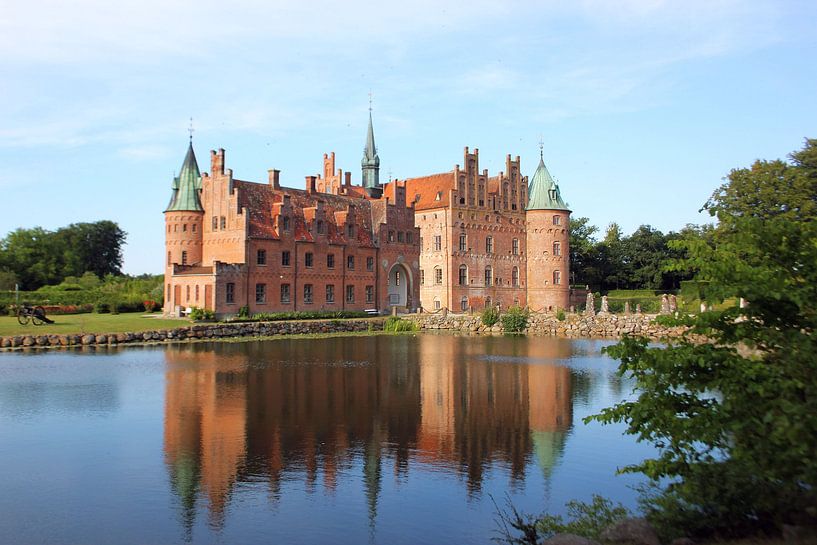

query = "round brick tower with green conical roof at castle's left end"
[165, 139, 204, 307]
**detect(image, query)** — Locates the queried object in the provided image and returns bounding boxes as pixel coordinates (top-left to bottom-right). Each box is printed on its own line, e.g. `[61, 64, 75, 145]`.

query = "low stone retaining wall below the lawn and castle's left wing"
[0, 320, 374, 349]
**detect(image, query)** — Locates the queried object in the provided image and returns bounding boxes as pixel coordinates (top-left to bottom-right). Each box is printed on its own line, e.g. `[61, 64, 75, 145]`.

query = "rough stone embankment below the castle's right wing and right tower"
[409, 313, 684, 339]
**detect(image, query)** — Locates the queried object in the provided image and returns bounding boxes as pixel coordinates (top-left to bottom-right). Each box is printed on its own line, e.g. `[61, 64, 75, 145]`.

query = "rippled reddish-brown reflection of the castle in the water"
[164, 335, 576, 525]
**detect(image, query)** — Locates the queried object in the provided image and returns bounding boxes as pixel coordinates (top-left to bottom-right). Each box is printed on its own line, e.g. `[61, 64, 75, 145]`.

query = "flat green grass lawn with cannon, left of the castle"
[0, 312, 190, 336]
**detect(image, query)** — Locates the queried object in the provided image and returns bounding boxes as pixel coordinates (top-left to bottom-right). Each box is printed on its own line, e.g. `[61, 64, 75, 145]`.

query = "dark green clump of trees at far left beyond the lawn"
[0, 221, 125, 290]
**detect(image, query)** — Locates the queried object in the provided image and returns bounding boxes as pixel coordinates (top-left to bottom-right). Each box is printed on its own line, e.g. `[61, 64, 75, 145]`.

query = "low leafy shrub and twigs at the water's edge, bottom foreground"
[490, 494, 631, 545]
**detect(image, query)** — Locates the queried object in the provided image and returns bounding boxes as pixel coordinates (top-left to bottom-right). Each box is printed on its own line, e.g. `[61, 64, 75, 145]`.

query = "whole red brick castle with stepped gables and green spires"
[159, 111, 570, 317]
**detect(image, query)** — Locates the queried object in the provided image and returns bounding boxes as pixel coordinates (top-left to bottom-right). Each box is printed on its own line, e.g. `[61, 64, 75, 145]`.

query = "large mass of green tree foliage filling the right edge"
[591, 140, 817, 537]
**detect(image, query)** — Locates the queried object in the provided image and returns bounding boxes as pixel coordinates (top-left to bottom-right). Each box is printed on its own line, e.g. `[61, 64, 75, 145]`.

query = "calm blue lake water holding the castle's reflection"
[0, 334, 650, 544]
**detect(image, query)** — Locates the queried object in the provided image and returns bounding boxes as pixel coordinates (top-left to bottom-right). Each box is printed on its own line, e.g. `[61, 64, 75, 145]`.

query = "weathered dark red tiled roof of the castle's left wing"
[233, 180, 375, 247]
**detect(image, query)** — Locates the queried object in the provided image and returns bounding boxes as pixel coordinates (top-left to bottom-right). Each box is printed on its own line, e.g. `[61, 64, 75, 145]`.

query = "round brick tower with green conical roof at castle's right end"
[525, 149, 570, 311]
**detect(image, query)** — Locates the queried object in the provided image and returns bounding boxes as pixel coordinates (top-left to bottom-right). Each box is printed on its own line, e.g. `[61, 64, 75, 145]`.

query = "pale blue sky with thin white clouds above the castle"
[0, 0, 817, 274]
